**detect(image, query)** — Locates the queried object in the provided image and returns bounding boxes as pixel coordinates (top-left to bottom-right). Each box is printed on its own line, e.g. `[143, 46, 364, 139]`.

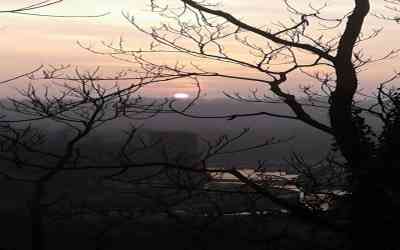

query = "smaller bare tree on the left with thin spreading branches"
[0, 66, 187, 250]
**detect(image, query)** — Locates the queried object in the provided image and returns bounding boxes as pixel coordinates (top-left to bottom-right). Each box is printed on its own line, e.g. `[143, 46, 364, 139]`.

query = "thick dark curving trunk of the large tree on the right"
[330, 0, 397, 250]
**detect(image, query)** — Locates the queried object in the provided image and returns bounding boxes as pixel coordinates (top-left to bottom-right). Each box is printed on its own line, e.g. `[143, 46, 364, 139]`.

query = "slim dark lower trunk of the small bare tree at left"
[29, 182, 45, 250]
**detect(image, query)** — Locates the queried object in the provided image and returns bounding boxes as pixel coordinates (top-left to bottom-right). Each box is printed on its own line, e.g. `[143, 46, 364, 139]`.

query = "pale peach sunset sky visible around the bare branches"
[0, 0, 400, 97]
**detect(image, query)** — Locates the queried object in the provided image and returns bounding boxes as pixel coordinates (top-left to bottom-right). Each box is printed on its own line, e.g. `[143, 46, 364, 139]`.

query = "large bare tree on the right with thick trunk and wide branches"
[78, 0, 399, 249]
